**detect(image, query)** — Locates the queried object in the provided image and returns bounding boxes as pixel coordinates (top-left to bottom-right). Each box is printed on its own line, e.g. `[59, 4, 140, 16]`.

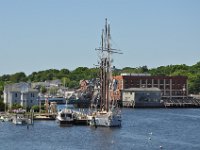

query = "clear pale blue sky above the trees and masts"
[0, 0, 200, 75]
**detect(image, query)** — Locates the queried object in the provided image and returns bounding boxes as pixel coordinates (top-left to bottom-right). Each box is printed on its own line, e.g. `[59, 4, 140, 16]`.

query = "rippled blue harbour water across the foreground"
[0, 109, 200, 150]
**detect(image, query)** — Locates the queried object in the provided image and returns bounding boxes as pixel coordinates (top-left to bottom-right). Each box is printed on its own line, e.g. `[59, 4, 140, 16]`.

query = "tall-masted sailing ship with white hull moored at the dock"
[90, 19, 122, 127]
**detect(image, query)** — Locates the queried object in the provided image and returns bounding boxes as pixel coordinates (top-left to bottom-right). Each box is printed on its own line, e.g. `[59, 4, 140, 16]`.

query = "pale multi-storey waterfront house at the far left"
[4, 82, 39, 107]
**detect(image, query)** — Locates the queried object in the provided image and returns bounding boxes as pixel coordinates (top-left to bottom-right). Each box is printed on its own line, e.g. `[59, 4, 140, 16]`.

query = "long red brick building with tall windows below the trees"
[114, 73, 188, 99]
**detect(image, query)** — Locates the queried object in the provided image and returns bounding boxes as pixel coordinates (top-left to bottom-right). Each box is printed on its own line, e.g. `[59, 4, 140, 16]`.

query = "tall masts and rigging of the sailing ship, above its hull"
[95, 18, 122, 112]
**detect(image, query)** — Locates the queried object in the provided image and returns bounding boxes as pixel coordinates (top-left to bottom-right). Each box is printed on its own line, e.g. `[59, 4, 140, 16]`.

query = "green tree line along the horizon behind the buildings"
[0, 62, 200, 95]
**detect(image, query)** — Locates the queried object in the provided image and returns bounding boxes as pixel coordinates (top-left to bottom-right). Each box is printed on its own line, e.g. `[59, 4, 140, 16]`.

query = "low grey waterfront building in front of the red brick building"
[122, 88, 164, 107]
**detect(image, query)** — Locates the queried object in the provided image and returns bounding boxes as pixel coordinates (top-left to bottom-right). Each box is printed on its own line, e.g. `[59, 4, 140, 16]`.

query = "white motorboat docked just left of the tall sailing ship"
[56, 109, 74, 126]
